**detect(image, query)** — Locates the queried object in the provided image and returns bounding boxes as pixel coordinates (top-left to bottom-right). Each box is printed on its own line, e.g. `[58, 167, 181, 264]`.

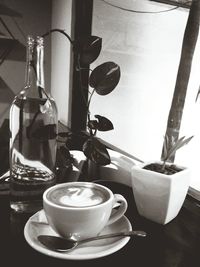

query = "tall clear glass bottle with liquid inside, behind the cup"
[10, 36, 58, 213]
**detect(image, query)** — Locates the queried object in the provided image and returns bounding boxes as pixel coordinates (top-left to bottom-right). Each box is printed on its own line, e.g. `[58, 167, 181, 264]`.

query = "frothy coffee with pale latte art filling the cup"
[47, 184, 110, 208]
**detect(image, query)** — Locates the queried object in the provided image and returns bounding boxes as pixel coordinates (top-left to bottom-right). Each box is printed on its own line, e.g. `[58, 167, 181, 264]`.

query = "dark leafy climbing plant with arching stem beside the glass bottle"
[43, 29, 121, 180]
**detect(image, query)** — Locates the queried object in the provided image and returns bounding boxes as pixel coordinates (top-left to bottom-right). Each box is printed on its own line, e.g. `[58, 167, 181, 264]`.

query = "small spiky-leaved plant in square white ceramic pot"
[132, 136, 193, 224]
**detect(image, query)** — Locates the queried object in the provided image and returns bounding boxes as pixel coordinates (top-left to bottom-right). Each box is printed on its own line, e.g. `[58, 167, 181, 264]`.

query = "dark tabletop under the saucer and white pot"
[0, 181, 200, 267]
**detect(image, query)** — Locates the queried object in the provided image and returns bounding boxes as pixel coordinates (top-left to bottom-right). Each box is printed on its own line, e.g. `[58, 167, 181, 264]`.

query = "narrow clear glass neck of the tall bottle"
[25, 37, 44, 91]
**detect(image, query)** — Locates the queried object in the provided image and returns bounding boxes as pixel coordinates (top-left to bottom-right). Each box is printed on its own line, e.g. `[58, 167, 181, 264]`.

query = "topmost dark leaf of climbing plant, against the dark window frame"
[74, 36, 102, 65]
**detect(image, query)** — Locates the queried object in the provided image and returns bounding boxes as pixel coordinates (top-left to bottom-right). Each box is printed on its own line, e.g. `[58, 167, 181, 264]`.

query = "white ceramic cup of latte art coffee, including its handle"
[43, 182, 127, 240]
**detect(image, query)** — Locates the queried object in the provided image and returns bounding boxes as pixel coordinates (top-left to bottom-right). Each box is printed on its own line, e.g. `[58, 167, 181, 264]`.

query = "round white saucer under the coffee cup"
[24, 210, 132, 260]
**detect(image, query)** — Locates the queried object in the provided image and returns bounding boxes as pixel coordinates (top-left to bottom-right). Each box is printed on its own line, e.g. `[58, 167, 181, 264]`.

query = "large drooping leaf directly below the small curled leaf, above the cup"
[83, 137, 110, 166]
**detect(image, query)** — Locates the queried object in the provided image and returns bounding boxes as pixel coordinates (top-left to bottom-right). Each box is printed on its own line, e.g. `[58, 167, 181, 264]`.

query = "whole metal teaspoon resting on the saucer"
[38, 231, 146, 252]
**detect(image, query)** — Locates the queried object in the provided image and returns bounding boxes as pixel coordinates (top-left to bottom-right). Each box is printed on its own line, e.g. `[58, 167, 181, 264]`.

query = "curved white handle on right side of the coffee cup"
[107, 194, 128, 225]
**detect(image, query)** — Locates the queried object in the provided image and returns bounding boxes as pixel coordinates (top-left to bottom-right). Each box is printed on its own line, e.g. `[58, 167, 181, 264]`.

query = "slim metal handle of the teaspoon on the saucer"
[78, 231, 147, 244]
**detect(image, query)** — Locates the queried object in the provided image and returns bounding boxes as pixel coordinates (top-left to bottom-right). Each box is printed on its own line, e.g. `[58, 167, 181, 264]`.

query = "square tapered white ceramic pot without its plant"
[132, 163, 190, 224]
